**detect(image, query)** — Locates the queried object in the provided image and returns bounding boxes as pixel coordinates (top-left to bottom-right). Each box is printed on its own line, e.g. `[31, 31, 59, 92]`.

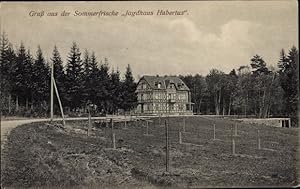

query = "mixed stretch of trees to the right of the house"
[180, 46, 299, 125]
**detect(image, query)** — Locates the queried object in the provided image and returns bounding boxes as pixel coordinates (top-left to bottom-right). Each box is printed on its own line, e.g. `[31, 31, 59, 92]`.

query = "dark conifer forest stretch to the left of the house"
[0, 33, 136, 116]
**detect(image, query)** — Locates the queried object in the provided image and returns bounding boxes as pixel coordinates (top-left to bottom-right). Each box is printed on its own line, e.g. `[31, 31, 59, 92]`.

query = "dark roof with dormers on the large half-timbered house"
[139, 75, 190, 91]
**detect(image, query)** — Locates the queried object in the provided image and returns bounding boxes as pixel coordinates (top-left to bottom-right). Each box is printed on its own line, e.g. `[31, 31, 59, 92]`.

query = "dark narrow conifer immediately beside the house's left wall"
[122, 64, 137, 111]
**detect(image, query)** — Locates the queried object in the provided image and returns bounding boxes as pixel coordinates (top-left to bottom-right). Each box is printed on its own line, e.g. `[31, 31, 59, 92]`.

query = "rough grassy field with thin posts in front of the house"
[1, 117, 299, 188]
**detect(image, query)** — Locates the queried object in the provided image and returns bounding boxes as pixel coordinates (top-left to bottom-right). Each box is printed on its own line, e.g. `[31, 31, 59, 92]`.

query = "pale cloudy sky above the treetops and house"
[0, 1, 298, 78]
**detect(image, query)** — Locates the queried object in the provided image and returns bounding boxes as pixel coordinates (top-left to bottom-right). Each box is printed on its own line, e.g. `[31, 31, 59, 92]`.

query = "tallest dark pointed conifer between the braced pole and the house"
[65, 42, 84, 110]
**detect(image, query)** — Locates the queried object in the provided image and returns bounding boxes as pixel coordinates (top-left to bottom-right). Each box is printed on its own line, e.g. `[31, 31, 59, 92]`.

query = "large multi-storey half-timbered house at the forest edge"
[136, 76, 193, 115]
